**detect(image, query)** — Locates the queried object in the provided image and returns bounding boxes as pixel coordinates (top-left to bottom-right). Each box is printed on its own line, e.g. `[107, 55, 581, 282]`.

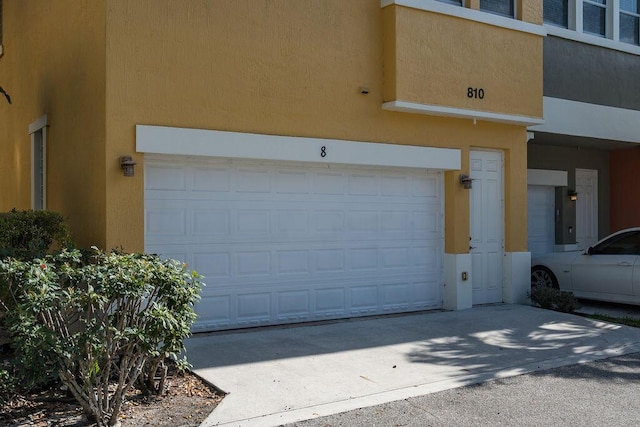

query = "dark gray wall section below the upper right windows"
[544, 36, 640, 110]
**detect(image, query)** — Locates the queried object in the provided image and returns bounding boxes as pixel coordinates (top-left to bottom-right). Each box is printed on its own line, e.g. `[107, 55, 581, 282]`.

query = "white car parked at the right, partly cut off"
[531, 227, 640, 305]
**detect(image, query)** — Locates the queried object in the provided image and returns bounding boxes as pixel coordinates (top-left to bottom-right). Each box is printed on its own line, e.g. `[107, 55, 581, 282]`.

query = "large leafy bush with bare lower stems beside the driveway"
[0, 248, 201, 426]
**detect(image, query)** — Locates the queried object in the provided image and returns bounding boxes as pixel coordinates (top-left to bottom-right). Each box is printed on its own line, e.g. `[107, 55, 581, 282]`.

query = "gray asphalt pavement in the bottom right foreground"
[287, 353, 640, 427]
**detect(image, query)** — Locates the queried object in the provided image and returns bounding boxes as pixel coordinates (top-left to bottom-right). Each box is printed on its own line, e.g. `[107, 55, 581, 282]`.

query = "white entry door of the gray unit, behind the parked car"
[576, 169, 598, 249]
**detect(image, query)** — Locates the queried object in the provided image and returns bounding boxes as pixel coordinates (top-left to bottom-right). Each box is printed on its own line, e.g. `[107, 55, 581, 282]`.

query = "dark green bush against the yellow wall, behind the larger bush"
[0, 209, 72, 261]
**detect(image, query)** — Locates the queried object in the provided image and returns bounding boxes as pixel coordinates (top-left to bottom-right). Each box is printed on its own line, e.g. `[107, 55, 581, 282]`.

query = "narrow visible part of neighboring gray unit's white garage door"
[527, 185, 555, 255]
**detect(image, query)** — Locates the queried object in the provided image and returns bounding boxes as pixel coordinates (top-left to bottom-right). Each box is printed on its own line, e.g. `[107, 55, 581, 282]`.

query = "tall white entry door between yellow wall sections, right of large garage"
[469, 151, 504, 304]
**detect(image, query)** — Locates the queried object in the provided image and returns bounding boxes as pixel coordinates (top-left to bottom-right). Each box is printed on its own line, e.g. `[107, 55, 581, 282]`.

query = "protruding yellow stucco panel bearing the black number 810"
[383, 6, 542, 118]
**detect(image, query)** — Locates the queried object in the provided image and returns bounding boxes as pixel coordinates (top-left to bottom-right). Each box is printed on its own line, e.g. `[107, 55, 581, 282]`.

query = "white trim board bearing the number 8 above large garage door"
[136, 125, 461, 170]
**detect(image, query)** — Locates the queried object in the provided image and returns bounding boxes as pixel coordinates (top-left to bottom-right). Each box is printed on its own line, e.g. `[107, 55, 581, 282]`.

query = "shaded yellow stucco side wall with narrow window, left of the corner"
[0, 0, 105, 246]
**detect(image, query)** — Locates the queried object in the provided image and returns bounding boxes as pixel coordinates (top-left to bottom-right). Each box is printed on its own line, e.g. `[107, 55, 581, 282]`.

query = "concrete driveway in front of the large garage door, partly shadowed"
[186, 305, 640, 426]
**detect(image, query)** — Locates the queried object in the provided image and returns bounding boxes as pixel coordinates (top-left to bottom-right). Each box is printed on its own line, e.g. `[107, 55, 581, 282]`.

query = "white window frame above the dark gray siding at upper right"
[544, 0, 640, 56]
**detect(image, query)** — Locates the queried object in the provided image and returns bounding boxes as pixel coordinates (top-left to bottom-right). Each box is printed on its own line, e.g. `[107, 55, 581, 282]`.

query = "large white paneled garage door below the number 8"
[145, 155, 444, 331]
